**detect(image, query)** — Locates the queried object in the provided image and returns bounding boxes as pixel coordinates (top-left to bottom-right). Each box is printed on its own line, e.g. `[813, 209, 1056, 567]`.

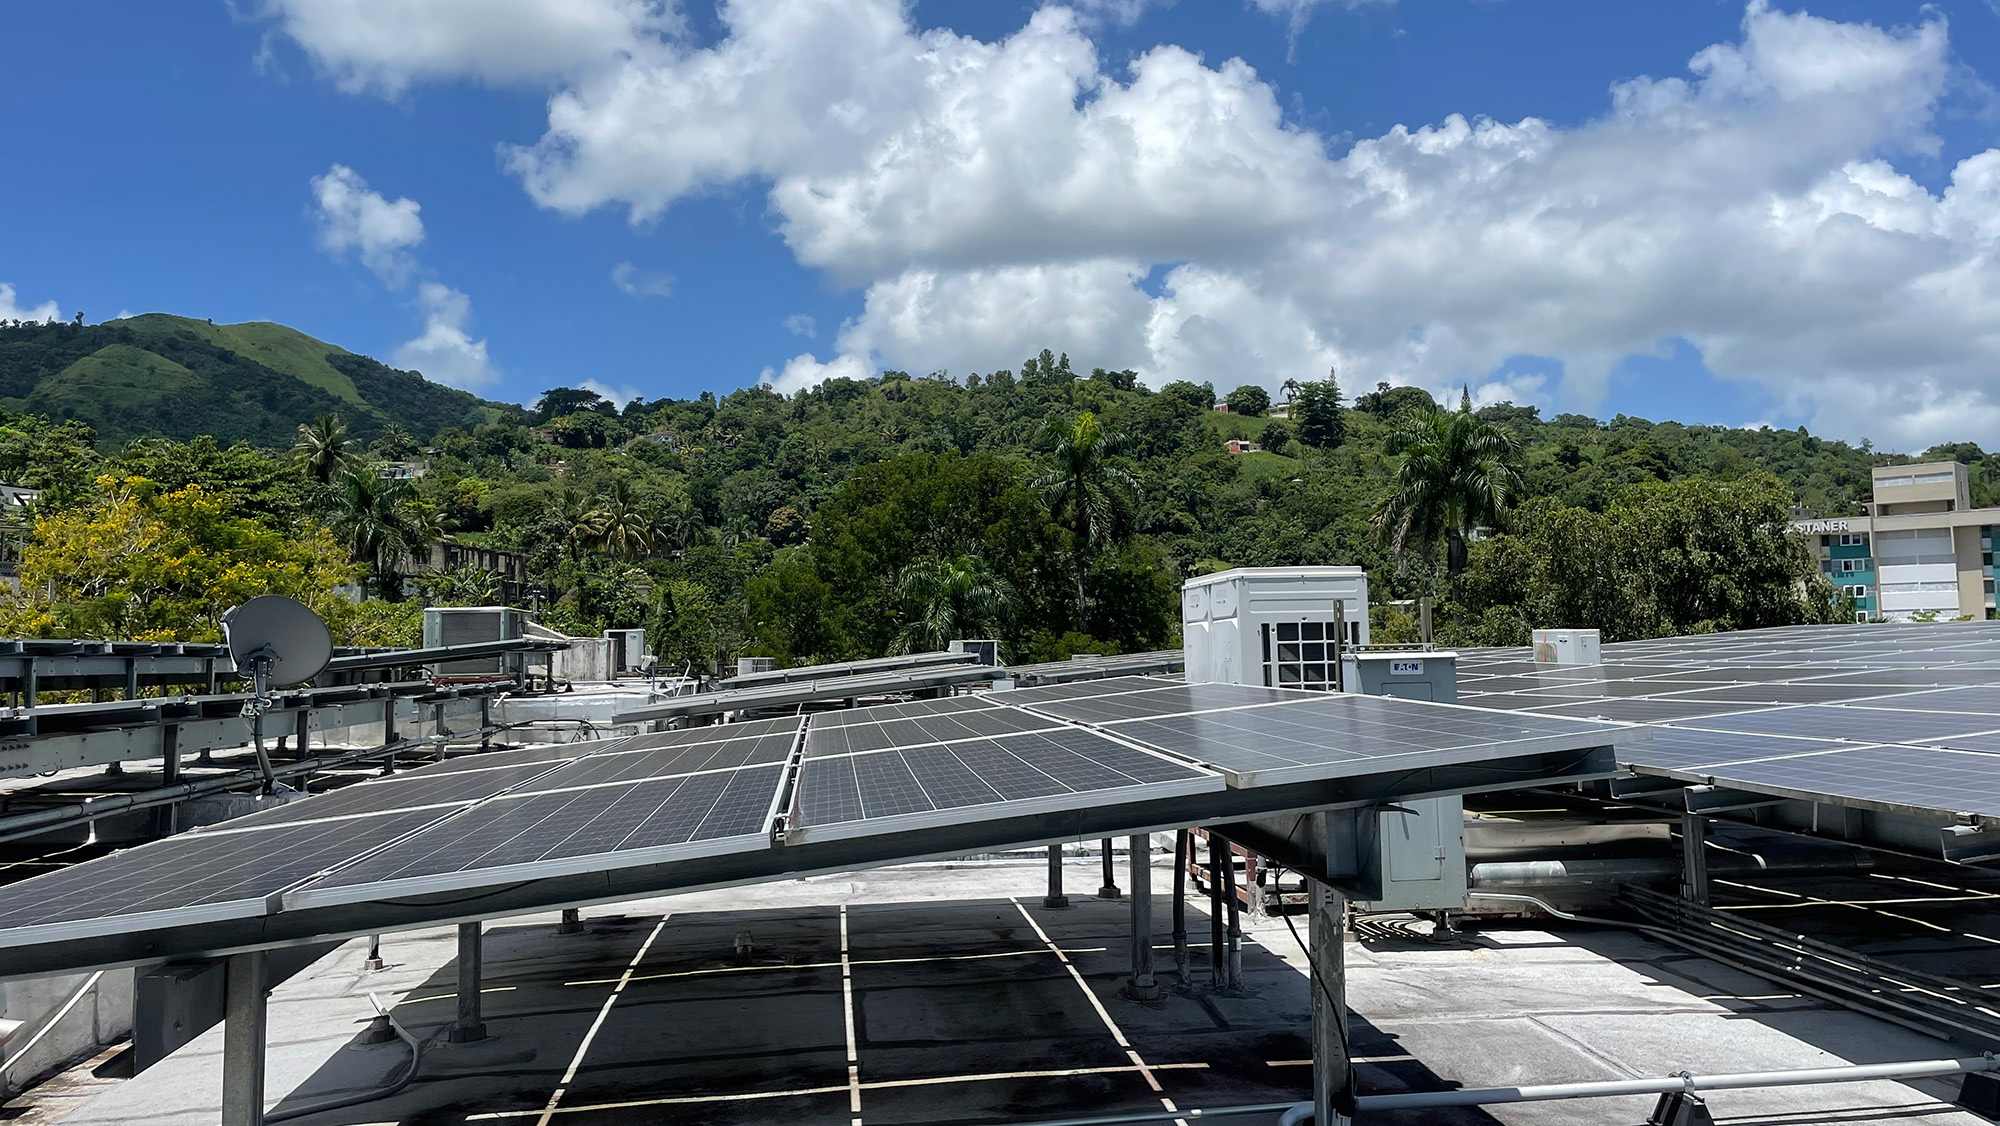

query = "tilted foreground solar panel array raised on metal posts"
[0, 676, 1632, 946]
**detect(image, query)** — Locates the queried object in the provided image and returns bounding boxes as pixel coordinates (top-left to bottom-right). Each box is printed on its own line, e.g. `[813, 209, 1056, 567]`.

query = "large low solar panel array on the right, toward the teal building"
[1458, 622, 2000, 816]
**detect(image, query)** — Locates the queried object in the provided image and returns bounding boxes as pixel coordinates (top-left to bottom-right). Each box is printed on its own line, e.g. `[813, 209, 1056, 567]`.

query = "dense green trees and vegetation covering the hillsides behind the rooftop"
[0, 318, 1996, 668]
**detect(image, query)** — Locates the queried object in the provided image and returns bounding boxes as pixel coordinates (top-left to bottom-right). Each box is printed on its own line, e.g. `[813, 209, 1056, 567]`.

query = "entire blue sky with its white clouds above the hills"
[0, 0, 2000, 446]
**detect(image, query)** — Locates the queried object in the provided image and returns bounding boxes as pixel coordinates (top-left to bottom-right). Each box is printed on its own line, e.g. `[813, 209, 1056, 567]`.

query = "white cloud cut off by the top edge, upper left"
[262, 0, 680, 96]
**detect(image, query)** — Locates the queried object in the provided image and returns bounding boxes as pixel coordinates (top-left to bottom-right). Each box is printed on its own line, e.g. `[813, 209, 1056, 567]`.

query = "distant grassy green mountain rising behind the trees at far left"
[0, 312, 520, 448]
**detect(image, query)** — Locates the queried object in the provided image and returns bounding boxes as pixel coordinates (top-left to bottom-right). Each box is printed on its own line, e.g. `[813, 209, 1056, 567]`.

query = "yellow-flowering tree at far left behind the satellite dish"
[0, 476, 362, 642]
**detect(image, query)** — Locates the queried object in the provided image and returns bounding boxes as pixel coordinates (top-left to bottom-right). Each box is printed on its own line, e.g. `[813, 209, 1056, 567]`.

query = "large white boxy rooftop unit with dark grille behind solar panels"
[1180, 566, 1368, 692]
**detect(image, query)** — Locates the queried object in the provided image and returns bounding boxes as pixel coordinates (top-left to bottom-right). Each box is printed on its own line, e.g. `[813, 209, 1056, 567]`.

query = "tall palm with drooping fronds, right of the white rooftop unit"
[1374, 390, 1522, 598]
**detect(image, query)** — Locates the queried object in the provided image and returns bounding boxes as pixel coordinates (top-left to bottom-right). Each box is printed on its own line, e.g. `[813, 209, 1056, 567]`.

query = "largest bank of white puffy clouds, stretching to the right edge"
[282, 0, 2000, 448]
